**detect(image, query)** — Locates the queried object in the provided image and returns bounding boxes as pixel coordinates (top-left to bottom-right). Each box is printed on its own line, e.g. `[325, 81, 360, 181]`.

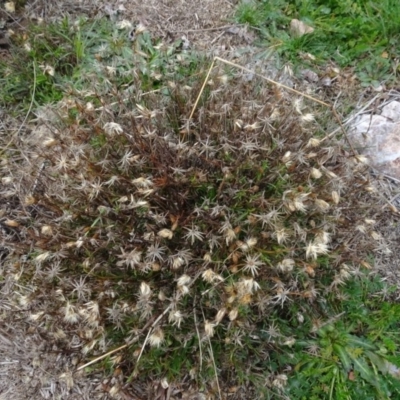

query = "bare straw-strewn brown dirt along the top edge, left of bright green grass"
[26, 0, 254, 51]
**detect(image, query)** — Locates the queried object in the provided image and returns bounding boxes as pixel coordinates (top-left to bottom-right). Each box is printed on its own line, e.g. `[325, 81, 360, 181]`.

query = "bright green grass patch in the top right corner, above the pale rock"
[237, 0, 400, 86]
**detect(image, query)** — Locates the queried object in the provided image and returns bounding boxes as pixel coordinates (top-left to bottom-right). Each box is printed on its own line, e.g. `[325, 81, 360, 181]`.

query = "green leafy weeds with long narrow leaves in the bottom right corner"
[289, 275, 400, 399]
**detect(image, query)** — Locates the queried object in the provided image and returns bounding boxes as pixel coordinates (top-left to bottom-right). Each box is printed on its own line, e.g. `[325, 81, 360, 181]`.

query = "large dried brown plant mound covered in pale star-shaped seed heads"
[0, 0, 398, 399]
